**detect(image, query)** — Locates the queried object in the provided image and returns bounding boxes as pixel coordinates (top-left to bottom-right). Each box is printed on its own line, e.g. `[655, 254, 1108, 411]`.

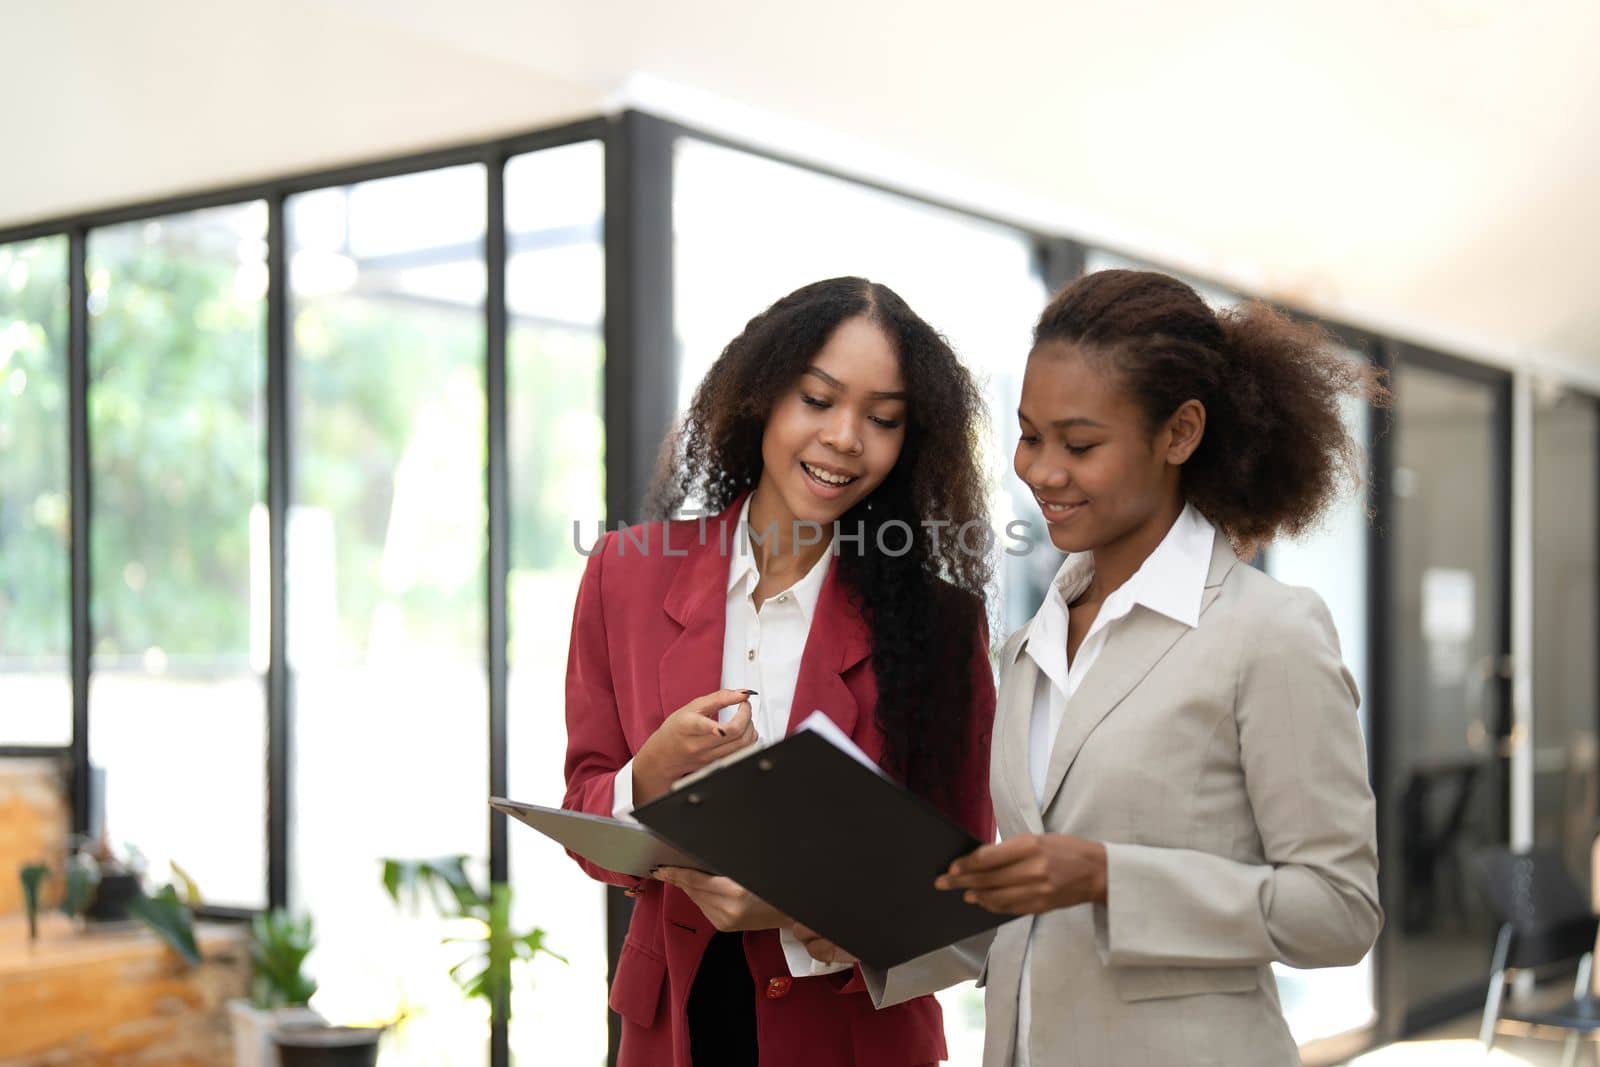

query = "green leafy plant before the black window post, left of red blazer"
[384, 856, 566, 1022]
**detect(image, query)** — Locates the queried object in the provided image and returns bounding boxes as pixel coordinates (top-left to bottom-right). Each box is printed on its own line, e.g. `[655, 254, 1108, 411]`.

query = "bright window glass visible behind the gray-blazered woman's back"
[1264, 367, 1376, 1043]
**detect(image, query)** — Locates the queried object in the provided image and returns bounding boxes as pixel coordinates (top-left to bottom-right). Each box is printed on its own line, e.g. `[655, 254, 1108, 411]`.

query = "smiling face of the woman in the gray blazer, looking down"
[1013, 341, 1205, 552]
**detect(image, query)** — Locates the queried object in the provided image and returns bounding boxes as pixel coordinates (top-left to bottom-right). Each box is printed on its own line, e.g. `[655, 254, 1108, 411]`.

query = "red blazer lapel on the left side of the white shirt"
[658, 498, 742, 718]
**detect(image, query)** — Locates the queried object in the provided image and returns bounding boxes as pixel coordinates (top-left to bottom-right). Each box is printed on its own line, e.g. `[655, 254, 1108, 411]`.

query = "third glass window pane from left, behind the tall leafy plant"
[286, 165, 488, 1067]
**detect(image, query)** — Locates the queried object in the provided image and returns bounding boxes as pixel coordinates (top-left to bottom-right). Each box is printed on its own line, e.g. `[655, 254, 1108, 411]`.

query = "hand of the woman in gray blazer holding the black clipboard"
[933, 833, 1106, 915]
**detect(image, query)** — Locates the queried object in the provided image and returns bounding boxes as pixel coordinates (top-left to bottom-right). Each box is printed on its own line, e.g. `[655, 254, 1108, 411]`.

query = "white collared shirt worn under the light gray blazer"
[1014, 504, 1216, 1067]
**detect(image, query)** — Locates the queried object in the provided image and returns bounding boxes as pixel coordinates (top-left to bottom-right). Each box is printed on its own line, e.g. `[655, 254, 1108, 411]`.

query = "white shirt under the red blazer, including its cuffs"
[611, 498, 848, 977]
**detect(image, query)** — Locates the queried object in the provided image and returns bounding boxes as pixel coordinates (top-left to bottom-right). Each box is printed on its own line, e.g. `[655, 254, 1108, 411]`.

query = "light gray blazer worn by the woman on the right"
[869, 531, 1382, 1067]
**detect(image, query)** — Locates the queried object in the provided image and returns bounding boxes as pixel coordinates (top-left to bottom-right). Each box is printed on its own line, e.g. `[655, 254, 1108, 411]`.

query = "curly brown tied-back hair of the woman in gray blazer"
[1034, 270, 1389, 558]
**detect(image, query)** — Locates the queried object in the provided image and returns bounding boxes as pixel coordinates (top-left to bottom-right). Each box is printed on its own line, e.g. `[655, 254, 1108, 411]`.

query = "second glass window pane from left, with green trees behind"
[88, 202, 267, 905]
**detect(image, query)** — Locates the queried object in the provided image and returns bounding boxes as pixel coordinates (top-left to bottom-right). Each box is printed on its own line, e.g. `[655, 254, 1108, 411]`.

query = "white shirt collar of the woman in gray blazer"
[1024, 504, 1216, 662]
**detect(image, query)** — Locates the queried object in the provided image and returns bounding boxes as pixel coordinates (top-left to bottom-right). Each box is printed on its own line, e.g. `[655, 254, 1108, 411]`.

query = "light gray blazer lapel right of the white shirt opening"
[1043, 530, 1238, 809]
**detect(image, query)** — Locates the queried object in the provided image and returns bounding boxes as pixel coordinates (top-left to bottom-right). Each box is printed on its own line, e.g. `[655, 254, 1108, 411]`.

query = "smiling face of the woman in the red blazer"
[750, 317, 906, 536]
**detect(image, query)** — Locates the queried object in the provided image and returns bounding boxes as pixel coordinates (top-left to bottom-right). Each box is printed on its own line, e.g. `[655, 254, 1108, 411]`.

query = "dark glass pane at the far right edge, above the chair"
[1533, 389, 1600, 881]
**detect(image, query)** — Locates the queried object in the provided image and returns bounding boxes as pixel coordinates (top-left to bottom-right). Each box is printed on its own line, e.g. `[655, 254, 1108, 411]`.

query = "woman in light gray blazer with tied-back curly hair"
[811, 270, 1386, 1067]
